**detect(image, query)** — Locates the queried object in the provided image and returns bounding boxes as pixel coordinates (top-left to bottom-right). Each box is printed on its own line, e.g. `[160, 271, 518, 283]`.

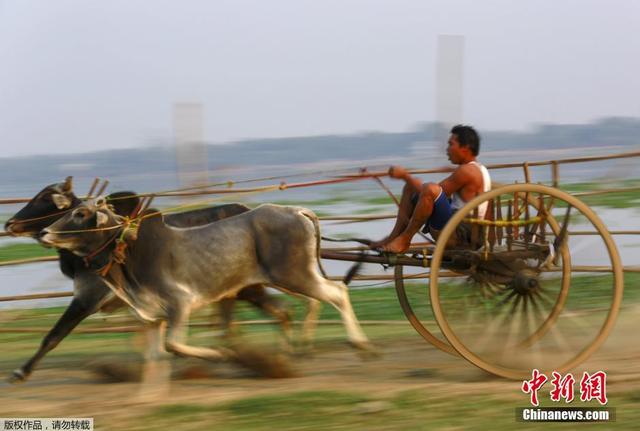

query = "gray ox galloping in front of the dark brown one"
[40, 199, 370, 360]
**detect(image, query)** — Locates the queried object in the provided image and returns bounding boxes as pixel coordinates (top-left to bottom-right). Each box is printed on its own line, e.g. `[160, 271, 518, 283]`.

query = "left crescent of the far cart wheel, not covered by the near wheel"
[394, 265, 458, 356]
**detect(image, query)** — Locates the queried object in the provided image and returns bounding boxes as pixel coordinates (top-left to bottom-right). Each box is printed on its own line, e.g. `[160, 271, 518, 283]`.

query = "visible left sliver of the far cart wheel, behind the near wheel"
[394, 265, 458, 356]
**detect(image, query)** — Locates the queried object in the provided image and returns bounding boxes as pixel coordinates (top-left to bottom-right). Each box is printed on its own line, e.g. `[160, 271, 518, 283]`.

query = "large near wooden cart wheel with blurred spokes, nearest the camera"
[430, 184, 623, 379]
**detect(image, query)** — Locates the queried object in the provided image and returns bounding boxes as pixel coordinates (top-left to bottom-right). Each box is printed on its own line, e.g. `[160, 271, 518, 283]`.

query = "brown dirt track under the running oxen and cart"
[0, 307, 640, 429]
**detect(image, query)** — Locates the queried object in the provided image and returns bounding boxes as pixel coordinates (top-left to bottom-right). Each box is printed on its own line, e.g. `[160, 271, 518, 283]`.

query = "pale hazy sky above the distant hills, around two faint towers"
[0, 0, 640, 156]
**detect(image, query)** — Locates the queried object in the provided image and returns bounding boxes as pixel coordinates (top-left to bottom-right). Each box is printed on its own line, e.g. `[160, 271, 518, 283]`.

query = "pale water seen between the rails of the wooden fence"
[0, 147, 640, 308]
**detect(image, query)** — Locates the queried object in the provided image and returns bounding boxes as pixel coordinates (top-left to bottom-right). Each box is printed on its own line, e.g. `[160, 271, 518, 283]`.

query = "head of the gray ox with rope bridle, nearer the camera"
[38, 197, 124, 256]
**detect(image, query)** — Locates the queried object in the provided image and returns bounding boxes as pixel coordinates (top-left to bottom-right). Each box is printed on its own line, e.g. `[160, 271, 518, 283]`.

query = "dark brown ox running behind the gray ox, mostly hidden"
[5, 177, 294, 382]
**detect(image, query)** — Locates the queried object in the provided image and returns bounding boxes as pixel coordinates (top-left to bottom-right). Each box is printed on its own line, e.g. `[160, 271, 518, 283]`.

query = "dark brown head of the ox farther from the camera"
[4, 177, 80, 237]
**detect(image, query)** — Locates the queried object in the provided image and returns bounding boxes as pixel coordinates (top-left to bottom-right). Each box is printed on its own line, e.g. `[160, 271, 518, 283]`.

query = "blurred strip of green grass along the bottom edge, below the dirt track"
[126, 390, 640, 431]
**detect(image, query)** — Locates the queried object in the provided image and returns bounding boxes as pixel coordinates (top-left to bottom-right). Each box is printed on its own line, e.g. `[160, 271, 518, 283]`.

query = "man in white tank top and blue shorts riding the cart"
[371, 125, 491, 253]
